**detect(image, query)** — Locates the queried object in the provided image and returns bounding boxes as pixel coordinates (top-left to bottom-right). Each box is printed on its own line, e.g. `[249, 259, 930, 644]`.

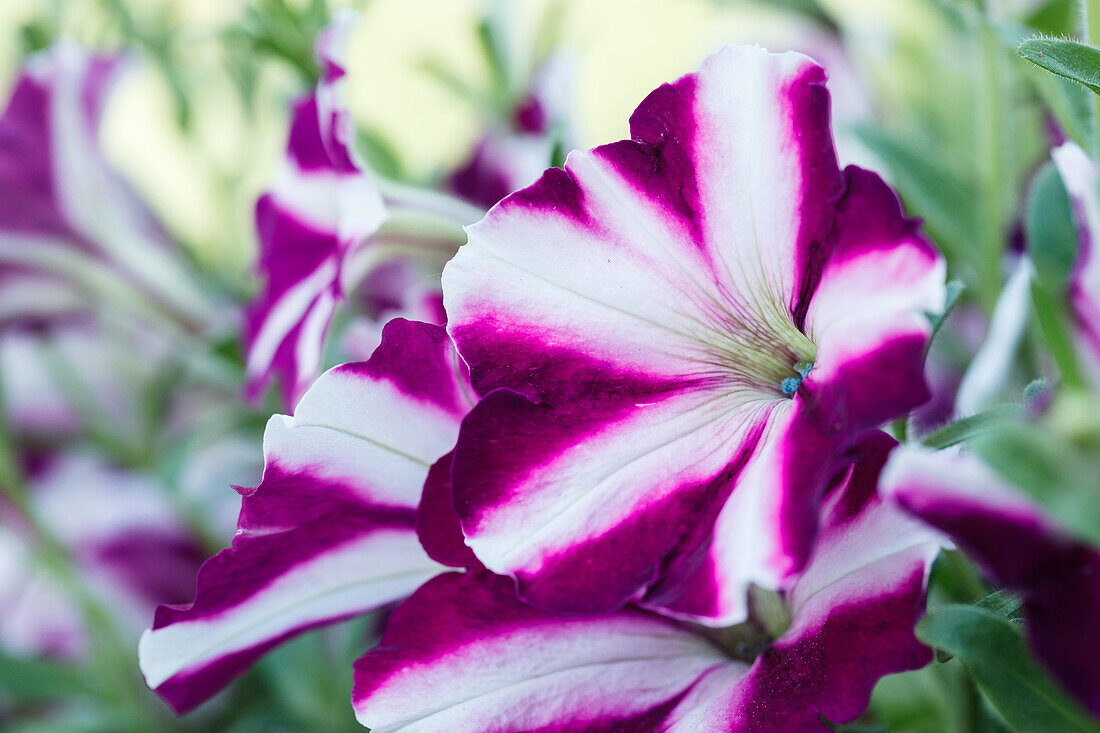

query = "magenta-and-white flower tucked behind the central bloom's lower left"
[139, 320, 472, 712]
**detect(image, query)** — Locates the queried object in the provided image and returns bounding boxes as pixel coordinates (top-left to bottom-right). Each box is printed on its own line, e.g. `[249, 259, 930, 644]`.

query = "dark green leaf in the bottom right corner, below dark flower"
[916, 605, 1100, 733]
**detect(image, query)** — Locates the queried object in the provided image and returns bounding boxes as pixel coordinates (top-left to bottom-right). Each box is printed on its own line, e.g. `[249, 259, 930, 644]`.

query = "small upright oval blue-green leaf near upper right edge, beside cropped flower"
[1024, 162, 1077, 292]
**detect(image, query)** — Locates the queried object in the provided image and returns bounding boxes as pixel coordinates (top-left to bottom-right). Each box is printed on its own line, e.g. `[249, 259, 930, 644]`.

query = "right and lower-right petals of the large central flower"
[646, 167, 944, 625]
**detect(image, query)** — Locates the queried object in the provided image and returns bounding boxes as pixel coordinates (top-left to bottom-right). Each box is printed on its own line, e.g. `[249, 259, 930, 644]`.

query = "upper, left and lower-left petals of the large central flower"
[443, 47, 842, 611]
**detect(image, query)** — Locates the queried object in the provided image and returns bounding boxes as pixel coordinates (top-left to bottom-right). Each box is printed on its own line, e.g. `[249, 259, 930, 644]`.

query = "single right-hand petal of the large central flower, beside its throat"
[803, 166, 946, 422]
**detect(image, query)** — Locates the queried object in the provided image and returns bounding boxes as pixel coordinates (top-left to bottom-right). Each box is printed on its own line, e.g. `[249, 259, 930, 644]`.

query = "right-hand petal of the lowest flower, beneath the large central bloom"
[686, 433, 941, 733]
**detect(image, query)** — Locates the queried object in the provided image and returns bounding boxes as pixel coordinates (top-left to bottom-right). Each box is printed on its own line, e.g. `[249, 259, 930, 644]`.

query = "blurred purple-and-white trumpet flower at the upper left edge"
[0, 41, 218, 329]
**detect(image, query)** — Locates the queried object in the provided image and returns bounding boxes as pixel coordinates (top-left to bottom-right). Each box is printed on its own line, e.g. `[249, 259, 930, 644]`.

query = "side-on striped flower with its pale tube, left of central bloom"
[244, 10, 480, 408]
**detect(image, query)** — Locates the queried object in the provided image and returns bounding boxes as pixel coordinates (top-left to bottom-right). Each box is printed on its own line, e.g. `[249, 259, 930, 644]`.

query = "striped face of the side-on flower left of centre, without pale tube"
[244, 11, 387, 408]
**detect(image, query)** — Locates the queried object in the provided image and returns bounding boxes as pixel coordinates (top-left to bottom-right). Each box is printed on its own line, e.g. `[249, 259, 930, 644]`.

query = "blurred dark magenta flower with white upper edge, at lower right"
[881, 446, 1100, 715]
